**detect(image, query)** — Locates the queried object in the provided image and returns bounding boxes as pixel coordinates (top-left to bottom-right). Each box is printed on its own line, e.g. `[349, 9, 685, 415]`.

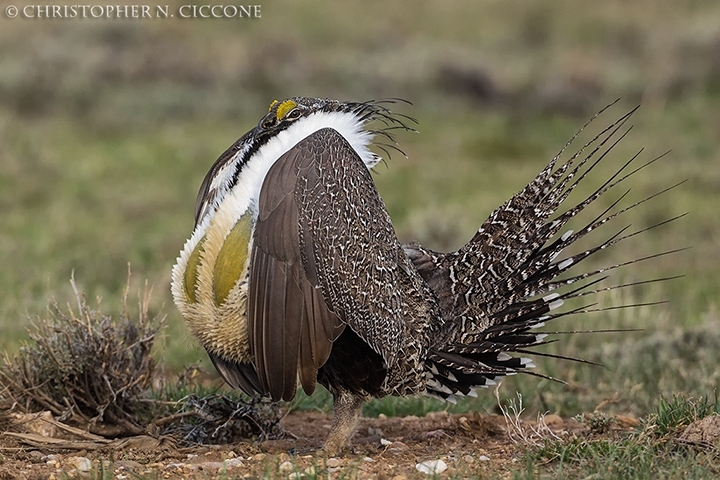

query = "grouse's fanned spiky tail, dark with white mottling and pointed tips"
[405, 102, 682, 401]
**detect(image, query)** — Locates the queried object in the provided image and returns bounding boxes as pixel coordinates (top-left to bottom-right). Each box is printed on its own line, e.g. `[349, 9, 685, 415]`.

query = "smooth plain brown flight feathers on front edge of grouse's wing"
[248, 128, 344, 400]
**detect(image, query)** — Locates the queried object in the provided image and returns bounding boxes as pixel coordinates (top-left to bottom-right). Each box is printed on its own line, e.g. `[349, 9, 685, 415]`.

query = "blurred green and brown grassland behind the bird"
[0, 0, 720, 412]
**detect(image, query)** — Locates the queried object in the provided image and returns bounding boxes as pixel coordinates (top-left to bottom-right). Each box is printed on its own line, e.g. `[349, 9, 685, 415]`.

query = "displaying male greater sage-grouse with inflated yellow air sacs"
[172, 97, 676, 455]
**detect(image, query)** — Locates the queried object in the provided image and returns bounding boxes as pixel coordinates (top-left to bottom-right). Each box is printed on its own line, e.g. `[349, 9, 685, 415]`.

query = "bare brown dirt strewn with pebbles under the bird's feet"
[0, 411, 608, 480]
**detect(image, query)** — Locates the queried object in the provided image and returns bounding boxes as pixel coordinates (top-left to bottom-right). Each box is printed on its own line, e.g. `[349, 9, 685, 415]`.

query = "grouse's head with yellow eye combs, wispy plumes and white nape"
[195, 97, 415, 226]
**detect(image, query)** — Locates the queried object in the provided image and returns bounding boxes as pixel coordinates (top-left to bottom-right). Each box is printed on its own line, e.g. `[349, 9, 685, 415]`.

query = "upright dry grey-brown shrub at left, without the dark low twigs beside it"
[0, 281, 162, 436]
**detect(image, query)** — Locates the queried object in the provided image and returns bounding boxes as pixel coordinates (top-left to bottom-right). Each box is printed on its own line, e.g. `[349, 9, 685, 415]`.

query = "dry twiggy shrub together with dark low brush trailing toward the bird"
[0, 279, 282, 444]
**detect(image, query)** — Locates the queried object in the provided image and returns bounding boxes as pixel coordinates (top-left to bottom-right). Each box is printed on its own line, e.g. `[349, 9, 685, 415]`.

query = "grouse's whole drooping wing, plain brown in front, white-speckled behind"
[248, 128, 408, 400]
